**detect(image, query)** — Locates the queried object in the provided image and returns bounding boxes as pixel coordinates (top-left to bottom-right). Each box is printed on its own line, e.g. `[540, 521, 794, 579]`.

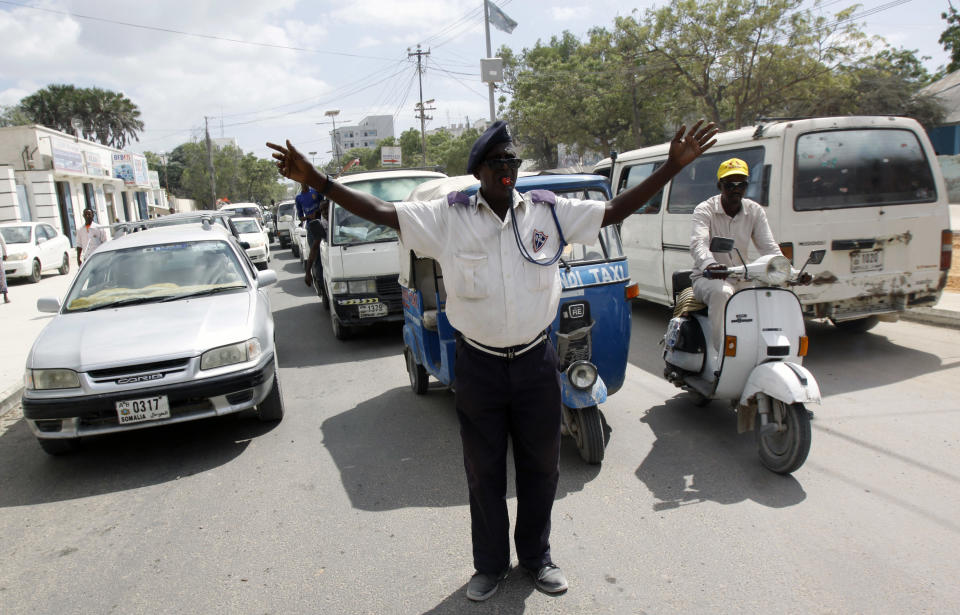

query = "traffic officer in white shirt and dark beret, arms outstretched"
[267, 121, 717, 600]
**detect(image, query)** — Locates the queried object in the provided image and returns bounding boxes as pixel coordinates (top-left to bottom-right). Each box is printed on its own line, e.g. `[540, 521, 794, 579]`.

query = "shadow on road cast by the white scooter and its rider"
[636, 393, 806, 511]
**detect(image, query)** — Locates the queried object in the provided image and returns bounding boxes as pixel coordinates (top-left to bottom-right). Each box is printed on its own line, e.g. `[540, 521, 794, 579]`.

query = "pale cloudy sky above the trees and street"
[0, 0, 949, 163]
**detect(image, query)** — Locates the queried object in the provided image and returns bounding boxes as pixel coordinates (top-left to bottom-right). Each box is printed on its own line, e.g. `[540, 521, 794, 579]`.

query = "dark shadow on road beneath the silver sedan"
[0, 412, 277, 508]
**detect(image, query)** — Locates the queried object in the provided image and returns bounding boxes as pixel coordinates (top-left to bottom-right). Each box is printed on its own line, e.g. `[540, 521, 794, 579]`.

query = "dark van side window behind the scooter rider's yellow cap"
[667, 147, 767, 214]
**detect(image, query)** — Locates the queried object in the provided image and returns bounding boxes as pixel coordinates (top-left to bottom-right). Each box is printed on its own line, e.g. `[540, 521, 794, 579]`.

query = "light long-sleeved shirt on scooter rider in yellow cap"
[690, 194, 783, 279]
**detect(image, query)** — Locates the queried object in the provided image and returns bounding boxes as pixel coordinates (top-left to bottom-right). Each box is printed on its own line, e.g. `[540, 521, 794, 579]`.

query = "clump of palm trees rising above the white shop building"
[19, 84, 144, 149]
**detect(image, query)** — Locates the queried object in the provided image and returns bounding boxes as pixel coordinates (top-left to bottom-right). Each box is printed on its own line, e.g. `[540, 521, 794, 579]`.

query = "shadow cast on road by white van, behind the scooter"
[628, 301, 955, 396]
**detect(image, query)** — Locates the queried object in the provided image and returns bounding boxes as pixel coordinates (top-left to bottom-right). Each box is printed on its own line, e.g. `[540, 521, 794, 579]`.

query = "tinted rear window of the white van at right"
[793, 128, 937, 211]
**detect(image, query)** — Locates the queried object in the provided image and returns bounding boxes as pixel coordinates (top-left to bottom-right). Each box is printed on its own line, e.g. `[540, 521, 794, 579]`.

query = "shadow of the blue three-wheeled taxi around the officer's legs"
[321, 387, 600, 511]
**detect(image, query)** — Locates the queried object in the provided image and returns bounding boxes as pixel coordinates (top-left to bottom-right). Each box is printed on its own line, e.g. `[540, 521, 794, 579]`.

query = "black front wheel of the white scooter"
[754, 399, 810, 474]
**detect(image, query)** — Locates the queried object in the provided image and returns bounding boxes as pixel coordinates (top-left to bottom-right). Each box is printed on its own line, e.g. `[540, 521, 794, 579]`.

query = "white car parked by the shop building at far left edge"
[0, 222, 70, 282]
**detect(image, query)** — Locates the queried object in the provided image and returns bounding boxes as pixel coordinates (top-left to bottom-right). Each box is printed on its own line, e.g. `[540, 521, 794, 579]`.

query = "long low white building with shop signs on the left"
[0, 125, 169, 244]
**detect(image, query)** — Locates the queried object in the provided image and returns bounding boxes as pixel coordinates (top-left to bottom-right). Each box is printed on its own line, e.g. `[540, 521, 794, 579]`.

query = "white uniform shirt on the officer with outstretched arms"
[396, 190, 606, 348]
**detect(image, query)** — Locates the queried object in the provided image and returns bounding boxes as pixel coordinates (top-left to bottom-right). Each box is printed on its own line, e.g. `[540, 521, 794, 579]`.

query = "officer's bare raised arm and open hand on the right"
[603, 120, 717, 226]
